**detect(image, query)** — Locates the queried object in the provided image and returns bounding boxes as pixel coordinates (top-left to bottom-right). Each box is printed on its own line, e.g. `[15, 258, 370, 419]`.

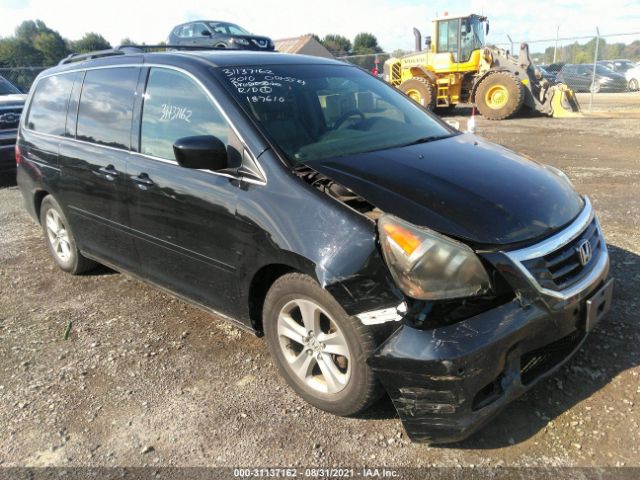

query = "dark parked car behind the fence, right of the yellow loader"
[556, 64, 627, 93]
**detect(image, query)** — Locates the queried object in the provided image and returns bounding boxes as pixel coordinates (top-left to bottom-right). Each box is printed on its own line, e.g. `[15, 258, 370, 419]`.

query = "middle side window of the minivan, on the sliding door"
[76, 67, 138, 148]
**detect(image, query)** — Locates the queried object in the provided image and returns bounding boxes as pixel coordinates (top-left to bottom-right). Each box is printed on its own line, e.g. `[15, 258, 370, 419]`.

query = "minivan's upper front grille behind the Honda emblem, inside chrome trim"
[522, 218, 604, 291]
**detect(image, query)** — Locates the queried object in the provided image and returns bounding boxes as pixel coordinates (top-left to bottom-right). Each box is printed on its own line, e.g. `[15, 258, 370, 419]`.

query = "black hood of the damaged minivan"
[308, 134, 583, 245]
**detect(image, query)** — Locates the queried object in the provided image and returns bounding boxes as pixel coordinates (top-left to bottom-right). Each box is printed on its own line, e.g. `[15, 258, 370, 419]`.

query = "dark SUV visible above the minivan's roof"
[169, 20, 274, 51]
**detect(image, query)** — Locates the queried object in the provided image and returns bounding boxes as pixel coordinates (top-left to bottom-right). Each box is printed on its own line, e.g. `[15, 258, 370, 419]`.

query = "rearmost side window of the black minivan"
[26, 73, 75, 135]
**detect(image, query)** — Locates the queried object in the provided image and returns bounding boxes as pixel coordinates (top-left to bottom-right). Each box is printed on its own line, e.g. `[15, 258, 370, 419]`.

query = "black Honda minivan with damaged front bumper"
[16, 50, 612, 443]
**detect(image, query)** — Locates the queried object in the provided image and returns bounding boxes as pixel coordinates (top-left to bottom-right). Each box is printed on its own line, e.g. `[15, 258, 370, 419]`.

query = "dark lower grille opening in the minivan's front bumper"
[520, 330, 585, 385]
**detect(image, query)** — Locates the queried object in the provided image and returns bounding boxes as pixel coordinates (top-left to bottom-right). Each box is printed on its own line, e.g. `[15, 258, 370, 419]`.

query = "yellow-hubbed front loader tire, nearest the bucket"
[475, 72, 524, 120]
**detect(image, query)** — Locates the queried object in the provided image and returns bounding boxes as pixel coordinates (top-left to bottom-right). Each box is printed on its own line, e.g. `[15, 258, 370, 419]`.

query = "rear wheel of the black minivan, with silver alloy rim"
[40, 195, 97, 275]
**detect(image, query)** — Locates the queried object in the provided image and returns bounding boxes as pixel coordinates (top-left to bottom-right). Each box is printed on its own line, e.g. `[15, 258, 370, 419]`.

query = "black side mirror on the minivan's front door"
[173, 135, 229, 171]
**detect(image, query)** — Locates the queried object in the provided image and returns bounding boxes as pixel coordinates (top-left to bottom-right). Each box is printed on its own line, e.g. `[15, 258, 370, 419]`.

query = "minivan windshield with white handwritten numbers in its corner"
[219, 65, 455, 164]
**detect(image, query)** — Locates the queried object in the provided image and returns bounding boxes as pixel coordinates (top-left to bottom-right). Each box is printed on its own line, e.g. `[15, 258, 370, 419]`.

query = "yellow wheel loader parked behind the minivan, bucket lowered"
[384, 14, 580, 120]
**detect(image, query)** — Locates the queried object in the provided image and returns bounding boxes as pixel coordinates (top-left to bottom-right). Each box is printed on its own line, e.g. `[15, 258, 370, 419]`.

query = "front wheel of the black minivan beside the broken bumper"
[263, 273, 383, 416]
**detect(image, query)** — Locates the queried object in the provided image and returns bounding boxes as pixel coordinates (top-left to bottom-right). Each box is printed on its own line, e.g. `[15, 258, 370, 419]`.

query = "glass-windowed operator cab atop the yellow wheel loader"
[431, 15, 489, 63]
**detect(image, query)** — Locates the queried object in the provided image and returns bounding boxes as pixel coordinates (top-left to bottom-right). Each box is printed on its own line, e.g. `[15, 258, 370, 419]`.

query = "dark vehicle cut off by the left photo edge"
[0, 76, 27, 174]
